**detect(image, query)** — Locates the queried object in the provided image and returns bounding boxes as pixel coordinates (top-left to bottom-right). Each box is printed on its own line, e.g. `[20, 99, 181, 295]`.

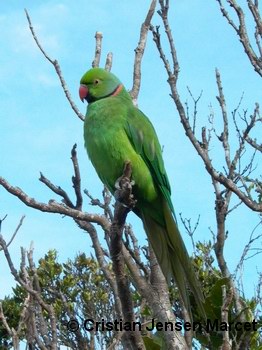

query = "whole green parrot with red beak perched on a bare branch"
[79, 68, 205, 315]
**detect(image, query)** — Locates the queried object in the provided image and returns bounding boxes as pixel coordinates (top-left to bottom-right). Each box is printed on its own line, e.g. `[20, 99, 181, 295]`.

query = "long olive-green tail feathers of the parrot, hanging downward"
[142, 201, 206, 319]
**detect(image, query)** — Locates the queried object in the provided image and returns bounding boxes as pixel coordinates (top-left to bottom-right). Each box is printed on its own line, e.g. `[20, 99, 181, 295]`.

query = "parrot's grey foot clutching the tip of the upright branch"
[114, 162, 137, 209]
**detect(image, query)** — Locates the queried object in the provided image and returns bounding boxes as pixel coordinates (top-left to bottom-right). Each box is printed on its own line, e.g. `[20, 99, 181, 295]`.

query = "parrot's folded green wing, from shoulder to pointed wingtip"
[126, 108, 175, 216]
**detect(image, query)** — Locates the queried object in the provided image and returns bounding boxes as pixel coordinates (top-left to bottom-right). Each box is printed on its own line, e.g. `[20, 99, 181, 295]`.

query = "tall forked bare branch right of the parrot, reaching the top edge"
[152, 4, 262, 318]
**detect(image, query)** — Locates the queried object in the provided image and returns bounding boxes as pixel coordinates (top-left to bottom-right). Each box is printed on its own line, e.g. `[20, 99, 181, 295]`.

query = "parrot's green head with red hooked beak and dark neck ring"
[79, 68, 123, 103]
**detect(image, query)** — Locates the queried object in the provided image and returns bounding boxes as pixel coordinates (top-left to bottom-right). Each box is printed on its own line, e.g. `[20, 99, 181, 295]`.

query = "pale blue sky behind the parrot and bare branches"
[0, 0, 261, 297]
